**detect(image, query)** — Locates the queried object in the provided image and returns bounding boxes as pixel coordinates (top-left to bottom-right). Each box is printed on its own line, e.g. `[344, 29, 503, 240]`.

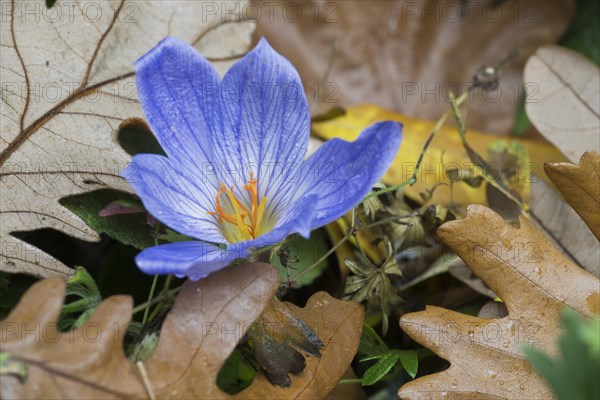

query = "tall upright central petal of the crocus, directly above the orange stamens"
[213, 39, 310, 198]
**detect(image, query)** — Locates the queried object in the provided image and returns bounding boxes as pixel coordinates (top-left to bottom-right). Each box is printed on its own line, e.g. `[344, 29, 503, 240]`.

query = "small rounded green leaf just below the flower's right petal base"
[271, 229, 330, 287]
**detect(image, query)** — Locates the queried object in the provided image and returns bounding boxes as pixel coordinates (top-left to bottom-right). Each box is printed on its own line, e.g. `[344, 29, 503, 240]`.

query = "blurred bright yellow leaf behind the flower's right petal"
[312, 104, 566, 207]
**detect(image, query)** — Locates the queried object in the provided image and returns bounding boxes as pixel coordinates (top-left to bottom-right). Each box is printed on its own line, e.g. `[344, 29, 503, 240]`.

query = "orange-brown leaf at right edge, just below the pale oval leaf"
[544, 152, 600, 240]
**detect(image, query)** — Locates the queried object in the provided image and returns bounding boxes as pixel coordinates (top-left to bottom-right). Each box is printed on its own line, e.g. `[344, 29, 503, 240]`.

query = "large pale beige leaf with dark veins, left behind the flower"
[0, 0, 253, 277]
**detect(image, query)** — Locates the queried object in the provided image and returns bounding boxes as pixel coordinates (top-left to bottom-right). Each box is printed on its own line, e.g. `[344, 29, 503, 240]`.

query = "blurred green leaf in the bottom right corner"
[523, 309, 600, 400]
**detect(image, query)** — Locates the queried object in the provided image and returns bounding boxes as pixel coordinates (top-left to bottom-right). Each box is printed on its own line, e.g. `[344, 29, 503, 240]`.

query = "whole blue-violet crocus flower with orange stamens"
[122, 37, 402, 280]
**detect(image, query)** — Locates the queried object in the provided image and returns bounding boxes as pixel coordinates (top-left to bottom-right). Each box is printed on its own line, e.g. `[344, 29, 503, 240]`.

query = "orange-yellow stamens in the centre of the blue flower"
[209, 172, 267, 241]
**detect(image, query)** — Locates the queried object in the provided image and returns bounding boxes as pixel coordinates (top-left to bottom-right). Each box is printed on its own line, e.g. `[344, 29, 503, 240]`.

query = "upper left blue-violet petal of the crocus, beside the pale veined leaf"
[135, 37, 220, 177]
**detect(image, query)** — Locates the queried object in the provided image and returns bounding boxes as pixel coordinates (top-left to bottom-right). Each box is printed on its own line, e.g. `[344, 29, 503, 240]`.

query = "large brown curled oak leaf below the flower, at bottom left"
[0, 263, 363, 399]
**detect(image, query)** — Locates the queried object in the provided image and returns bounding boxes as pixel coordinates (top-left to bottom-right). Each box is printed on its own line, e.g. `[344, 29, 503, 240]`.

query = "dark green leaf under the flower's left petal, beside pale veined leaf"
[60, 190, 154, 250]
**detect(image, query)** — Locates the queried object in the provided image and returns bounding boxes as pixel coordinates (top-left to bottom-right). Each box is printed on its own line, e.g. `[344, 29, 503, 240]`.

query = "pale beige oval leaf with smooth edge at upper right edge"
[525, 46, 600, 163]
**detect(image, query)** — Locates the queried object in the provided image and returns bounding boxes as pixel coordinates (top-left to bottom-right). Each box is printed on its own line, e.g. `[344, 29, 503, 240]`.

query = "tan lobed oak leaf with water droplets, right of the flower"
[398, 205, 600, 399]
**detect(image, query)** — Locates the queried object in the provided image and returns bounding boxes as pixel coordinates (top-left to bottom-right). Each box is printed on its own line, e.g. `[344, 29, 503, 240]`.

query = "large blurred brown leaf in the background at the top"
[255, 0, 573, 133]
